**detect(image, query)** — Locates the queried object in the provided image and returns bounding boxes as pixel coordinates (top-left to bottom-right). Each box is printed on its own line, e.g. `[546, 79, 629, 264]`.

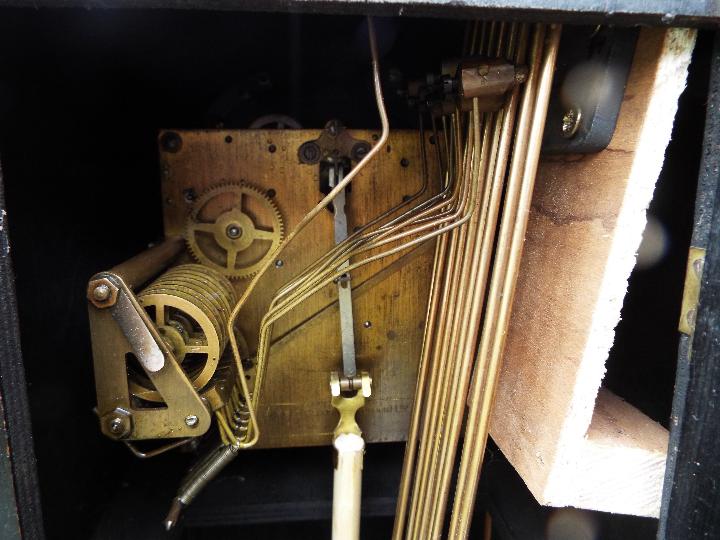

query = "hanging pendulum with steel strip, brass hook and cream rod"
[328, 164, 371, 540]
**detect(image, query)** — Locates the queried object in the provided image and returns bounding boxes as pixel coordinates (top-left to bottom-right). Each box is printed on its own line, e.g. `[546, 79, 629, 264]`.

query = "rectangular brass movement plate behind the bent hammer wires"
[160, 129, 437, 447]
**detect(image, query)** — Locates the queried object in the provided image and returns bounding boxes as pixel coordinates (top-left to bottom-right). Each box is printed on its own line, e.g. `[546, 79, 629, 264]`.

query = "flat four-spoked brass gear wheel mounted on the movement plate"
[185, 182, 285, 279]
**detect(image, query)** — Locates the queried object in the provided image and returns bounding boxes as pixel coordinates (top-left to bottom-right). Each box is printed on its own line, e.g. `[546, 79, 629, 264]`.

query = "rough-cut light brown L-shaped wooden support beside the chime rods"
[491, 29, 695, 516]
